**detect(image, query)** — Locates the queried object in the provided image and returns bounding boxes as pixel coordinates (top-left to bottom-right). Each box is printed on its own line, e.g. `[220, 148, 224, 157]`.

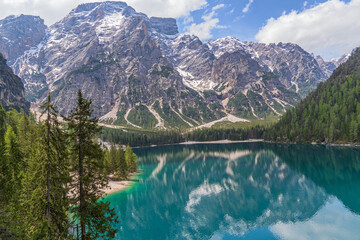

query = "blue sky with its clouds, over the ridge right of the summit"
[178, 0, 360, 60]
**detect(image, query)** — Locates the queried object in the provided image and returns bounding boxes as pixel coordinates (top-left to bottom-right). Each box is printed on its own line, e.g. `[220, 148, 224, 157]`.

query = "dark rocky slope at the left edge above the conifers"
[0, 54, 30, 112]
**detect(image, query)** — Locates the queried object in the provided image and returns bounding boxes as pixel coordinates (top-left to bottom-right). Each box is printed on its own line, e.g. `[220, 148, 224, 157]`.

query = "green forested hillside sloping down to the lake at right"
[265, 48, 360, 143]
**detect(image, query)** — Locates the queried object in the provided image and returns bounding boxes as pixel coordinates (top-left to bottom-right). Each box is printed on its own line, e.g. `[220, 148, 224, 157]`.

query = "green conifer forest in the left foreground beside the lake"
[0, 91, 137, 239]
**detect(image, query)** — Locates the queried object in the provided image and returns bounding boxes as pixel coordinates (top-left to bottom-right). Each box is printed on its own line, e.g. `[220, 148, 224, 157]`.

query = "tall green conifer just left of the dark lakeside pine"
[24, 94, 70, 239]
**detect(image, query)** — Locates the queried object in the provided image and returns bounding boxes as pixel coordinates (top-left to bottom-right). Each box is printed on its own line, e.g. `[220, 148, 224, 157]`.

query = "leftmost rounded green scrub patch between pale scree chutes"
[128, 105, 157, 128]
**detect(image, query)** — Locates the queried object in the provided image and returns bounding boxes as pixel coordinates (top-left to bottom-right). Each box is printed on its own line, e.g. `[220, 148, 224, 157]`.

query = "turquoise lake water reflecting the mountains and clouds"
[106, 143, 360, 240]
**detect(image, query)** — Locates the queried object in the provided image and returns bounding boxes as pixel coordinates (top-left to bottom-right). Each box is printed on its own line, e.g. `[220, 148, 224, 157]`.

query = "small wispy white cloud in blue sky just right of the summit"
[185, 4, 225, 40]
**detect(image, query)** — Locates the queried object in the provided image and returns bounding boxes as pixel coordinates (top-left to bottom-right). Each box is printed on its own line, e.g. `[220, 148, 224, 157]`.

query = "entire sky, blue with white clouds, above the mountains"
[0, 0, 360, 60]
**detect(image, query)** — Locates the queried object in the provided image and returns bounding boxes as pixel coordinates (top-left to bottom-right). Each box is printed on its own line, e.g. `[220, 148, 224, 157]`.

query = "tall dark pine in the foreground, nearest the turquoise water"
[64, 90, 118, 240]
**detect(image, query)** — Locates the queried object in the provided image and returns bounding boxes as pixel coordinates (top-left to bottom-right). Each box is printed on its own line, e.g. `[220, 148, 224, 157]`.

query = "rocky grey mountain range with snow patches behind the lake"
[0, 2, 348, 128]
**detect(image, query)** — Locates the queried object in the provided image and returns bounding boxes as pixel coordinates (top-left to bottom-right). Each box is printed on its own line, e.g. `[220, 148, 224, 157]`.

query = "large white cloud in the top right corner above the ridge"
[255, 0, 360, 59]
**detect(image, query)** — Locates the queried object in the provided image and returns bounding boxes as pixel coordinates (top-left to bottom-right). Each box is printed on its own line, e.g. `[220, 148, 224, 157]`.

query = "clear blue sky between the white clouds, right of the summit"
[178, 0, 338, 41]
